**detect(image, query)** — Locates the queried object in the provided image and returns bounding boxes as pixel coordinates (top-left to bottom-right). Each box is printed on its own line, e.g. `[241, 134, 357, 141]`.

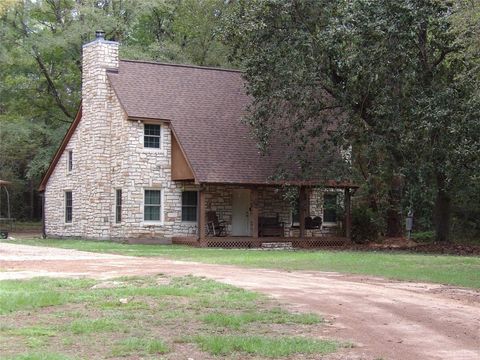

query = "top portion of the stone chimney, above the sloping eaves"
[82, 30, 118, 114]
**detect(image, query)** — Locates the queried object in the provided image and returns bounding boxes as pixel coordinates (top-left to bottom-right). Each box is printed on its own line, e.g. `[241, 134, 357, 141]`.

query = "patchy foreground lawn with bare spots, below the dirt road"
[0, 275, 342, 360]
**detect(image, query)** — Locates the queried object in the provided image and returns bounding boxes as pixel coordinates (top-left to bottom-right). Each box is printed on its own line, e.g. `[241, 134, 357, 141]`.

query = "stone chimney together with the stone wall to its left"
[45, 40, 118, 239]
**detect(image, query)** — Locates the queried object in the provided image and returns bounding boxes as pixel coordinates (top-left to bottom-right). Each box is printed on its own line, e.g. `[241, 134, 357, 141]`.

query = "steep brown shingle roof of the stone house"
[108, 61, 288, 184]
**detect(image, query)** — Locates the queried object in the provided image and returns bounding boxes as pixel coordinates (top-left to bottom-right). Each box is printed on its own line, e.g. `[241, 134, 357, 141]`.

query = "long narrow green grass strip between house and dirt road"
[3, 239, 480, 288]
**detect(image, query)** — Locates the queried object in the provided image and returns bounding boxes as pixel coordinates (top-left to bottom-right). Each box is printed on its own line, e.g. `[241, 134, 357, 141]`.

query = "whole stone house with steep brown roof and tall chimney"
[40, 32, 352, 248]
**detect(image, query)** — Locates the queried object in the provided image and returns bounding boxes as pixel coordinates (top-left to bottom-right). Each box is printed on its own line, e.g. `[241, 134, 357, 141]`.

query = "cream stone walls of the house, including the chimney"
[45, 39, 336, 243]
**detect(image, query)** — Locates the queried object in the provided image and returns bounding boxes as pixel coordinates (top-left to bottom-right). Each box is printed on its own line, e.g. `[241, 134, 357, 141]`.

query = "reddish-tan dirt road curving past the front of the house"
[0, 243, 480, 360]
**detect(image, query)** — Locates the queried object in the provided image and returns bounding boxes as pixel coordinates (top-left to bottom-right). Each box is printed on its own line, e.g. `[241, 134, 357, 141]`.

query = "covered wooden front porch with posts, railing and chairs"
[172, 183, 356, 249]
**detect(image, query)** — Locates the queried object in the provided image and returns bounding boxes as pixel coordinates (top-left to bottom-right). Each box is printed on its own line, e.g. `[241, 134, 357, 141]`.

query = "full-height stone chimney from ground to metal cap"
[79, 31, 118, 238]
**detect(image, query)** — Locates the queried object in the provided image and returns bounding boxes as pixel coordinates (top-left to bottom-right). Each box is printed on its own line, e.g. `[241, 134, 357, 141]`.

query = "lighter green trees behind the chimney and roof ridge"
[0, 0, 232, 218]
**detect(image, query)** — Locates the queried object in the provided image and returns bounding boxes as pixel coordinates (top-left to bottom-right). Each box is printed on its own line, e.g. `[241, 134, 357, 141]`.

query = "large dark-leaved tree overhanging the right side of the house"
[226, 0, 479, 241]
